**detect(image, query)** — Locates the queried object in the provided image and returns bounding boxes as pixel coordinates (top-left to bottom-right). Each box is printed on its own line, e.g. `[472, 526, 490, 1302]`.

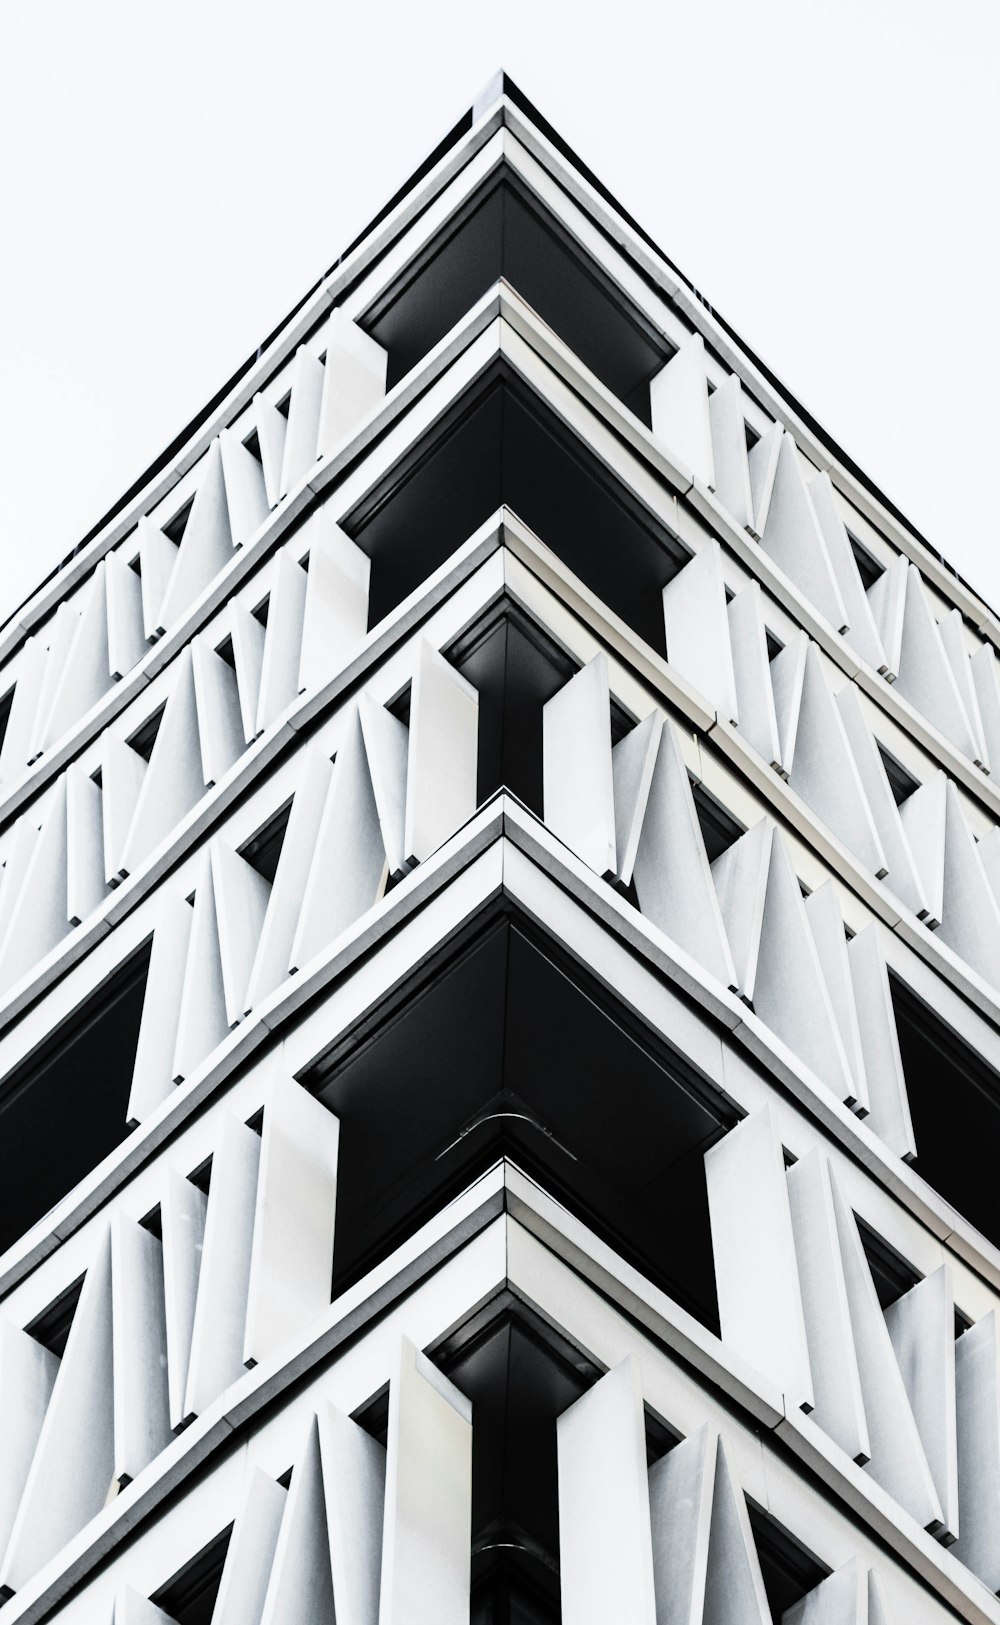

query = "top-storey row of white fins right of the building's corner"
[650, 335, 1000, 772]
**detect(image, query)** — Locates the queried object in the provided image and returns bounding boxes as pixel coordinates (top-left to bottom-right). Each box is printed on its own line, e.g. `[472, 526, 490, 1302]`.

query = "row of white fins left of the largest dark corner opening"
[0, 1076, 340, 1591]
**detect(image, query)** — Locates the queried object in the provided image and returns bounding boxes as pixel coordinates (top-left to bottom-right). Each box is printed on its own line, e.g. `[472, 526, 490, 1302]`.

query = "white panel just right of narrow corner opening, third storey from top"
[541, 653, 616, 874]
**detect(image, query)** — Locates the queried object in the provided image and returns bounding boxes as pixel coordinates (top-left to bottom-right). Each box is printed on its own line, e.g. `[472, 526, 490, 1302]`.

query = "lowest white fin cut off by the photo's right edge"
[953, 1310, 1000, 1591]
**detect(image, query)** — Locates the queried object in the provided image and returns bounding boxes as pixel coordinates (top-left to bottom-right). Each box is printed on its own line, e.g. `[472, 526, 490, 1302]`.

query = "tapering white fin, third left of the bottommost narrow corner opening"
[260, 1417, 338, 1625]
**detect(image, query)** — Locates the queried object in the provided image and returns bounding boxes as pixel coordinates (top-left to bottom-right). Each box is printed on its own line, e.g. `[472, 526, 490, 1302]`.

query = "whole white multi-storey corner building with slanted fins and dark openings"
[0, 78, 1000, 1625]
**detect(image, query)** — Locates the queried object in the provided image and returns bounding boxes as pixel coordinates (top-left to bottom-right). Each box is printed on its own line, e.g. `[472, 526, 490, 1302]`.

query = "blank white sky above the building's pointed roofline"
[0, 0, 1000, 616]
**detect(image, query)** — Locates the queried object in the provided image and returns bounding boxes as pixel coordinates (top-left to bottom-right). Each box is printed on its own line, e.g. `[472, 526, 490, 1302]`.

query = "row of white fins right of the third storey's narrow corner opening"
[543, 655, 915, 1157]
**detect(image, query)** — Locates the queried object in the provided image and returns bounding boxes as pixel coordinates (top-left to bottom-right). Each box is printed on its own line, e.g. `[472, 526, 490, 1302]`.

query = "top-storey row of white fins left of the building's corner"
[0, 310, 387, 785]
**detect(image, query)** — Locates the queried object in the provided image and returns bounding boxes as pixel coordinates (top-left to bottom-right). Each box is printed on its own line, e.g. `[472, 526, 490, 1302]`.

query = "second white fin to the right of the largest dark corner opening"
[785, 1147, 872, 1464]
